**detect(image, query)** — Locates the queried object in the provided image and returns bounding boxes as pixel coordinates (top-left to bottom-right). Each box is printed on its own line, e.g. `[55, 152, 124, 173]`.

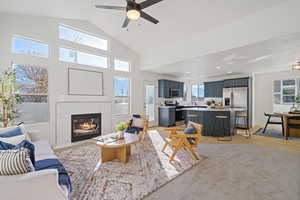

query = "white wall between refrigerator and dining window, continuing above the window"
[253, 71, 300, 126]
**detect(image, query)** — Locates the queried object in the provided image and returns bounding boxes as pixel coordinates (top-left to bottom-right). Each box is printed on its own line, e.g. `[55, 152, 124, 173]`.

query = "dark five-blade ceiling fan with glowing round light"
[95, 0, 162, 28]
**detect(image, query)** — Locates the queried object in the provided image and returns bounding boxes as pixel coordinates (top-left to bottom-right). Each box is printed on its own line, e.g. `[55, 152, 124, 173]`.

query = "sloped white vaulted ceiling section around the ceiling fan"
[91, 0, 282, 56]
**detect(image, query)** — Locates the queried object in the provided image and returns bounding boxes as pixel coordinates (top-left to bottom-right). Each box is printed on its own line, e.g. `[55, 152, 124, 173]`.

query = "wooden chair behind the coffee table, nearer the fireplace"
[126, 114, 149, 141]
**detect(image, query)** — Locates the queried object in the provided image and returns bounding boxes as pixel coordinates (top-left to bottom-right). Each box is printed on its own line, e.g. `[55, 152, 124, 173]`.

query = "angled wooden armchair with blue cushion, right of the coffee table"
[162, 121, 203, 161]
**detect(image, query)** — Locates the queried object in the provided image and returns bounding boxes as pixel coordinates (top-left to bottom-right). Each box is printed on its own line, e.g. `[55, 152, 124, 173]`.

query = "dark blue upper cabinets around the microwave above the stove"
[158, 79, 184, 98]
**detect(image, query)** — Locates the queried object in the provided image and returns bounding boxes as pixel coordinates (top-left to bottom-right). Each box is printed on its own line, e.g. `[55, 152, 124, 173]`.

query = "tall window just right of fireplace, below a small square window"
[112, 77, 129, 115]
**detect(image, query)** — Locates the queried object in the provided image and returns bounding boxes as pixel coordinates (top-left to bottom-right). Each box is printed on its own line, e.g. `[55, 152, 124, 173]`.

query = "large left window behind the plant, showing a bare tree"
[13, 65, 49, 123]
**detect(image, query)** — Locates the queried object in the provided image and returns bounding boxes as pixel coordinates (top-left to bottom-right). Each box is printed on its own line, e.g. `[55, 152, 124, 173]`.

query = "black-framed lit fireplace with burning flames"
[71, 113, 101, 142]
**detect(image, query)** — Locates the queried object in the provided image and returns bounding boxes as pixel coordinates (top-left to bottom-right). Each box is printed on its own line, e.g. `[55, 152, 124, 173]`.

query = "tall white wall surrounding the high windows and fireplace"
[0, 13, 173, 145]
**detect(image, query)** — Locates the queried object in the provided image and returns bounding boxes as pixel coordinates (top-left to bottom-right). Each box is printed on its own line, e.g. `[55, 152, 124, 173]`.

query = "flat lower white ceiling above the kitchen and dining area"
[146, 33, 300, 80]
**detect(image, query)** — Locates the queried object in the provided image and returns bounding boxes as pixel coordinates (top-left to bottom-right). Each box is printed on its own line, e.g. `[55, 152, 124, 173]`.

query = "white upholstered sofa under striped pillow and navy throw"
[0, 141, 69, 200]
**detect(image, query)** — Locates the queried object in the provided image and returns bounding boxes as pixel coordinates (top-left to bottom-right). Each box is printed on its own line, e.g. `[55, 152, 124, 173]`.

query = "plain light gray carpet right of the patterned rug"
[145, 144, 300, 200]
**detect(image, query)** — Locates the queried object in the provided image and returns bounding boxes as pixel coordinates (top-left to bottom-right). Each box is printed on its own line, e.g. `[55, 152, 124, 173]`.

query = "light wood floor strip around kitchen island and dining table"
[152, 127, 300, 153]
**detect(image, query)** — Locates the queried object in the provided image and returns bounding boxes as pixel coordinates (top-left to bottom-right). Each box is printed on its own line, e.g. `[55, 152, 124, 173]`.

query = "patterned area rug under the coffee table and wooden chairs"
[56, 130, 206, 200]
